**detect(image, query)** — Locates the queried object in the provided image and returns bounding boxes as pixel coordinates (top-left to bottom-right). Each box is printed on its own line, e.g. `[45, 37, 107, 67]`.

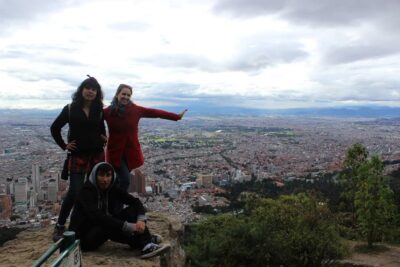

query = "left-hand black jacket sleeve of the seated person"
[77, 188, 124, 229]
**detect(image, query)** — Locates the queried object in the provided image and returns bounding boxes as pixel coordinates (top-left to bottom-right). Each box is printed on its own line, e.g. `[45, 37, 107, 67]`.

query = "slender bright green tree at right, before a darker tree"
[354, 156, 395, 247]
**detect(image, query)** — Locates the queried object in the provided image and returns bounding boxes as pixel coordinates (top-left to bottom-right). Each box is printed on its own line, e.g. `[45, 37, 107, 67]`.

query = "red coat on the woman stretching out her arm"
[104, 104, 180, 170]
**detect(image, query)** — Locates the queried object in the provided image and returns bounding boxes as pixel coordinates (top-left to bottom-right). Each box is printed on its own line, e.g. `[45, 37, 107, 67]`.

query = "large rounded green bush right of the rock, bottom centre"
[185, 194, 345, 266]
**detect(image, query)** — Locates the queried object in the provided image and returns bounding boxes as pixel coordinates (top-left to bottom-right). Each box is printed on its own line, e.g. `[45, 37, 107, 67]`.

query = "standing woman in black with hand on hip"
[50, 76, 107, 242]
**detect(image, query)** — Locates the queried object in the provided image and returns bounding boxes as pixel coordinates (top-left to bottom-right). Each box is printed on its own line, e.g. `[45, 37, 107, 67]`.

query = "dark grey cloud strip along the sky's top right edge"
[214, 0, 400, 26]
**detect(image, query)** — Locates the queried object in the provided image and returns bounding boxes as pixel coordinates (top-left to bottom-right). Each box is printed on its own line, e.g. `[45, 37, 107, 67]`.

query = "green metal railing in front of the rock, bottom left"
[32, 231, 82, 267]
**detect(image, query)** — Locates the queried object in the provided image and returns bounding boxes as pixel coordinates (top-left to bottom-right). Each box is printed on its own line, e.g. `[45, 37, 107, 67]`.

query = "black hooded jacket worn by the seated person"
[69, 163, 145, 237]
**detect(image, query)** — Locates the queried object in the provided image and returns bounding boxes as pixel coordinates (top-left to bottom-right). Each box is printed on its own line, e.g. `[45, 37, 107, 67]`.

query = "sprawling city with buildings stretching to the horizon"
[0, 114, 400, 228]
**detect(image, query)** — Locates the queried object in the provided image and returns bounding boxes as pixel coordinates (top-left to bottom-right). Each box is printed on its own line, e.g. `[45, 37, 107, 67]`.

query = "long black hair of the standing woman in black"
[72, 75, 103, 112]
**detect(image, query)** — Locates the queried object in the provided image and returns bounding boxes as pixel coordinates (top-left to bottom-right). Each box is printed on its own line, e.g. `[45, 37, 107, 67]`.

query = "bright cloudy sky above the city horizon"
[0, 0, 400, 110]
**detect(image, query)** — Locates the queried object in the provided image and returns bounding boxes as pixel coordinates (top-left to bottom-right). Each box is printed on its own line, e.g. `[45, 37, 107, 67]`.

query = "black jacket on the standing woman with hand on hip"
[50, 104, 106, 154]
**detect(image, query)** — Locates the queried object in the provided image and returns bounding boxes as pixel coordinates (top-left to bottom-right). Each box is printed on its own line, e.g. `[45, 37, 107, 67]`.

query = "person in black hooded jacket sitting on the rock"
[69, 162, 170, 259]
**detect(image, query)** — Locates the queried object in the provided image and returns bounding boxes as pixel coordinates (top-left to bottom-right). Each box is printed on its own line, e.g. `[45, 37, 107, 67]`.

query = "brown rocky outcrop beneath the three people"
[0, 213, 185, 267]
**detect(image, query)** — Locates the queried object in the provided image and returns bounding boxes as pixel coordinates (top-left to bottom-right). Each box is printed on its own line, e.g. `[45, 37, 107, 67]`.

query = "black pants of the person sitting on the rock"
[80, 207, 151, 251]
